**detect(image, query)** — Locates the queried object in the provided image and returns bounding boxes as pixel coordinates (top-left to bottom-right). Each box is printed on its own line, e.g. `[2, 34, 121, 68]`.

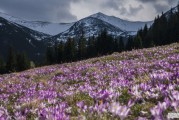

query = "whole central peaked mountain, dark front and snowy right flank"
[45, 13, 153, 41]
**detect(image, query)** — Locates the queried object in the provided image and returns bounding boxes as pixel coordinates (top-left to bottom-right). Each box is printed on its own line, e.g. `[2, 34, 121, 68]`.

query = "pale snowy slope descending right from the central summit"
[90, 12, 153, 32]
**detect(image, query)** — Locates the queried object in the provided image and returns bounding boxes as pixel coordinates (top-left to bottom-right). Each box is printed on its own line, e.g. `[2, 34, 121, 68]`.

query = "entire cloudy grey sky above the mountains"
[0, 0, 178, 23]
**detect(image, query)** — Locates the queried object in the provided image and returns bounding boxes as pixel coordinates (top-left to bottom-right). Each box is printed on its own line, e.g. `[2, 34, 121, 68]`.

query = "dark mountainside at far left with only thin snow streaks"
[0, 17, 49, 60]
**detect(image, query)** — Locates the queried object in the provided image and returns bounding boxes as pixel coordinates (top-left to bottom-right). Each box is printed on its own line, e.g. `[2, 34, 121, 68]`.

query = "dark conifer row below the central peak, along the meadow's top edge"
[46, 29, 125, 64]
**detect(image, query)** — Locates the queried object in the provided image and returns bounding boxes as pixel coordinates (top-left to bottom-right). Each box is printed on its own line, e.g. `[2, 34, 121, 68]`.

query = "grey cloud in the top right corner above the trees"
[137, 0, 177, 13]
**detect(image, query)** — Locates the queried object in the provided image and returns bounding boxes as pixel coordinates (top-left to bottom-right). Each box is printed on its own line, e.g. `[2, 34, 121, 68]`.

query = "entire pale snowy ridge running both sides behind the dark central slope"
[0, 12, 152, 36]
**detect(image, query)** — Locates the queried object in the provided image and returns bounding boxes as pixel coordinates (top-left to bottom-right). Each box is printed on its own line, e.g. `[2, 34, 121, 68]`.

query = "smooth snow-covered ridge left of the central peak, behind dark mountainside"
[0, 12, 74, 35]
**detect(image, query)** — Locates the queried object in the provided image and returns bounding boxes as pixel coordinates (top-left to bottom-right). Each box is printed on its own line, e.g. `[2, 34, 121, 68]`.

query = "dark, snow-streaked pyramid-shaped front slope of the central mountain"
[46, 17, 124, 40]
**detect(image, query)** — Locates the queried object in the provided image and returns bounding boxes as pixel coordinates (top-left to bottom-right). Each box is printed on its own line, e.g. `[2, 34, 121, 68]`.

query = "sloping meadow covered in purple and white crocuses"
[0, 43, 179, 120]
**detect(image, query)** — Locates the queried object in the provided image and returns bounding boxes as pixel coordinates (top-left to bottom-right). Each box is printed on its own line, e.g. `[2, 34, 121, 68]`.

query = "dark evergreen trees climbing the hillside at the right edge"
[130, 5, 179, 48]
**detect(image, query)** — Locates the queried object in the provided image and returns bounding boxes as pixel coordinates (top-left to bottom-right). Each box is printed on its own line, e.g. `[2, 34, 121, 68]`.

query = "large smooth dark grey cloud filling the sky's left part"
[0, 0, 78, 22]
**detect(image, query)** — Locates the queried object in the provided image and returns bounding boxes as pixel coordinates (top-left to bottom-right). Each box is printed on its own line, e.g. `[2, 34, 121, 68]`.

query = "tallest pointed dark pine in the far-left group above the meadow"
[6, 47, 17, 72]
